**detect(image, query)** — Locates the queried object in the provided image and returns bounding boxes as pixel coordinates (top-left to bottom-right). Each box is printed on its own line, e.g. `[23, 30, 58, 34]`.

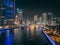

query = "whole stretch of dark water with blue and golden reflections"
[0, 28, 51, 45]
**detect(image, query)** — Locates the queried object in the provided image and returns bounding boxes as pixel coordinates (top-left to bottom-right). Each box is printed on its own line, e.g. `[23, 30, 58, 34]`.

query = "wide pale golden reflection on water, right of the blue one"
[14, 29, 22, 45]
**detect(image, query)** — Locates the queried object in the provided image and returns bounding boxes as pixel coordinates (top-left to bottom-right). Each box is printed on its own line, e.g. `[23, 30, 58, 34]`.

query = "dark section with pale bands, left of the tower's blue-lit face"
[0, 0, 5, 26]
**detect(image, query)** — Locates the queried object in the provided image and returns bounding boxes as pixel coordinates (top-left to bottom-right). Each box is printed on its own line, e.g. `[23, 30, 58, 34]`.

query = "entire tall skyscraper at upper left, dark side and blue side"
[0, 0, 15, 24]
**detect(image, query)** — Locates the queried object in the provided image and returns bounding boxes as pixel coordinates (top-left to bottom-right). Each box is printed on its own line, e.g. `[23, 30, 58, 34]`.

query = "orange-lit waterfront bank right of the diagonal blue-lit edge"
[44, 30, 60, 45]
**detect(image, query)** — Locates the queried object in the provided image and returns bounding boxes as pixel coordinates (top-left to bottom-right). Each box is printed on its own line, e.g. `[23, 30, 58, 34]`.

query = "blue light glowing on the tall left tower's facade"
[4, 0, 14, 18]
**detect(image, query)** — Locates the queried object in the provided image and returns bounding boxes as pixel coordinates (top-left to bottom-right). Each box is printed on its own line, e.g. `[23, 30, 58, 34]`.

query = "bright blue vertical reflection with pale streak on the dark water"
[5, 30, 14, 45]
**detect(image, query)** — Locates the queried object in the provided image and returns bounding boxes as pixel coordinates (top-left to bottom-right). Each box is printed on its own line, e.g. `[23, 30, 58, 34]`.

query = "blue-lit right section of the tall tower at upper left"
[3, 0, 15, 19]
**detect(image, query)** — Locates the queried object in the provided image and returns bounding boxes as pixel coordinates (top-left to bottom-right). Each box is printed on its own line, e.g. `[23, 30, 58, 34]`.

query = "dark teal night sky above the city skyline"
[16, 0, 60, 17]
